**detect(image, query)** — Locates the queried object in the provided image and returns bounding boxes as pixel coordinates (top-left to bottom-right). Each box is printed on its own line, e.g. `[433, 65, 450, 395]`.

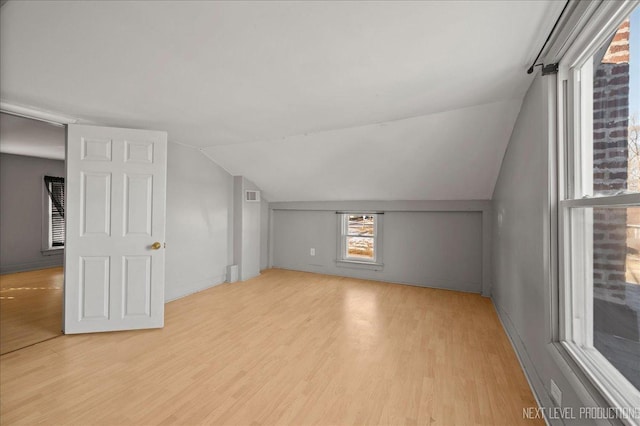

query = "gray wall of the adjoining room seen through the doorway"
[0, 154, 65, 273]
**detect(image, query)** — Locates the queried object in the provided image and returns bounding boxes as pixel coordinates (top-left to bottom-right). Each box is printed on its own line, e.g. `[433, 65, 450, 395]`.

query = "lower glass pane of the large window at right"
[577, 207, 640, 389]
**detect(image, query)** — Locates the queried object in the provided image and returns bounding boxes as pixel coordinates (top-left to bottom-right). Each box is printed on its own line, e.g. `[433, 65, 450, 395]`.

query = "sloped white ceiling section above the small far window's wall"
[204, 100, 520, 201]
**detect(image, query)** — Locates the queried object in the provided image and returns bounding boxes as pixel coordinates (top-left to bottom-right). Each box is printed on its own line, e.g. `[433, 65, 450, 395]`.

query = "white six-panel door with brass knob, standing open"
[64, 125, 167, 334]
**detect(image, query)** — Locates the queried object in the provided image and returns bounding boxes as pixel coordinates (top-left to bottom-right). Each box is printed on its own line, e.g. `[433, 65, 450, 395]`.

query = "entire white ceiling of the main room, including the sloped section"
[0, 0, 563, 201]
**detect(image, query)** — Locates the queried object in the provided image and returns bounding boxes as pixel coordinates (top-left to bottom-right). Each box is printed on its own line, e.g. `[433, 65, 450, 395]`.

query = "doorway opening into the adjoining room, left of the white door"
[0, 112, 66, 354]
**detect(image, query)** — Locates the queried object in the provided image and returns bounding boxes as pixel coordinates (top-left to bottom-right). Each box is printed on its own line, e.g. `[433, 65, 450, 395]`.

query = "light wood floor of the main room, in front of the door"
[0, 270, 544, 426]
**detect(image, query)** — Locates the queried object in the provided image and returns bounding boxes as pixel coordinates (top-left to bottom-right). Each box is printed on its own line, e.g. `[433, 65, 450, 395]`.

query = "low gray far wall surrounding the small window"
[271, 202, 483, 293]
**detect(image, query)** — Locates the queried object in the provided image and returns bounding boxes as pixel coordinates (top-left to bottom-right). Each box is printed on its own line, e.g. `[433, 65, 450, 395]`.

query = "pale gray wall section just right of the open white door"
[165, 143, 233, 300]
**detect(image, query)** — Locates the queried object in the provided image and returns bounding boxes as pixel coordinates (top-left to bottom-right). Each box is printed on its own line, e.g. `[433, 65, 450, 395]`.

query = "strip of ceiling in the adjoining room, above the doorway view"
[0, 114, 66, 160]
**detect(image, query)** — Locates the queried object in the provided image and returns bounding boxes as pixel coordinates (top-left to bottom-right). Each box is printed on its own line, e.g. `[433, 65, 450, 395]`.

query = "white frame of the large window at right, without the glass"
[554, 0, 640, 425]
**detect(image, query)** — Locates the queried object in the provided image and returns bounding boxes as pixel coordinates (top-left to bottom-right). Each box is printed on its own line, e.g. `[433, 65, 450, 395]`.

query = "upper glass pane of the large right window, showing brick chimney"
[585, 8, 640, 196]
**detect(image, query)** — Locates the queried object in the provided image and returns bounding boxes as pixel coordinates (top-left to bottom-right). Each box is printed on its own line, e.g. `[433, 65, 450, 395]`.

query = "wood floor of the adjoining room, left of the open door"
[0, 267, 64, 354]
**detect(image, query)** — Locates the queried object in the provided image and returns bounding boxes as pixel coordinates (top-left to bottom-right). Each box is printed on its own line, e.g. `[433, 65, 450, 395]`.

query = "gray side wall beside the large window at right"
[492, 76, 604, 425]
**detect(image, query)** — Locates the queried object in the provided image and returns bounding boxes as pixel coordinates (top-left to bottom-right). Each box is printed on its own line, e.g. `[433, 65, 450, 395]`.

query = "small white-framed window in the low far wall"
[340, 213, 379, 263]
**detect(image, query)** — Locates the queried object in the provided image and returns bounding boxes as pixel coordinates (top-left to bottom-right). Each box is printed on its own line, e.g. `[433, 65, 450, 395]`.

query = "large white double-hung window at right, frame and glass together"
[559, 3, 640, 416]
